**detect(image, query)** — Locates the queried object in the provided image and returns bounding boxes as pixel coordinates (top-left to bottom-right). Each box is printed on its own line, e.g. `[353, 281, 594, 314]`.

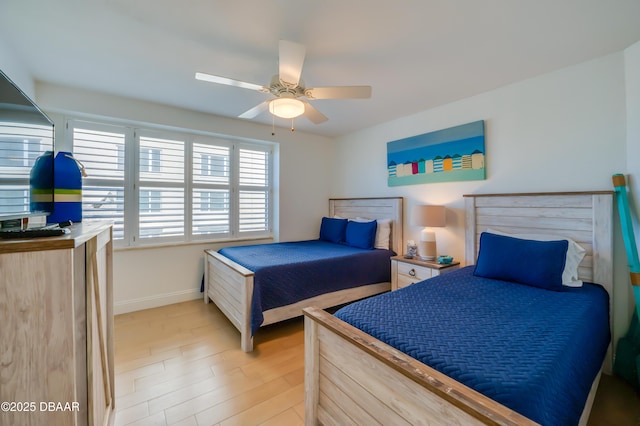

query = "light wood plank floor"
[115, 300, 640, 426]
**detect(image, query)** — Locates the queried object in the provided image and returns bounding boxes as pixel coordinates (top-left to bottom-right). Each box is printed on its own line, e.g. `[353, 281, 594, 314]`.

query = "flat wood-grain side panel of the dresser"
[0, 250, 75, 425]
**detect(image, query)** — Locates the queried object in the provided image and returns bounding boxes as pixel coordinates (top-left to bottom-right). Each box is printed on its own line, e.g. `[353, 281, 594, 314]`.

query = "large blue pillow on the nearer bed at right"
[473, 232, 569, 291]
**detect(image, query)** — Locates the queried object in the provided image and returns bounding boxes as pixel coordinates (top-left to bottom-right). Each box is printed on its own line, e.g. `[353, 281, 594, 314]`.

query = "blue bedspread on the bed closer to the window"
[219, 240, 395, 333]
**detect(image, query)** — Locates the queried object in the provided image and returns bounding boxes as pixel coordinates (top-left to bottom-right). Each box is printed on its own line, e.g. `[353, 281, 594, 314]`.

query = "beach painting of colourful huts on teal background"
[387, 120, 486, 186]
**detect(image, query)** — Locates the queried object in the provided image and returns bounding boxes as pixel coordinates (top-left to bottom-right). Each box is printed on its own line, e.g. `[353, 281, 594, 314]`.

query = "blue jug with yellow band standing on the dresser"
[47, 151, 82, 223]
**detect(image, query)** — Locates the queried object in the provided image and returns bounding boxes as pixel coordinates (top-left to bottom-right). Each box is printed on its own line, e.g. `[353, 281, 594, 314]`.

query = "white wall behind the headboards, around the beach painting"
[333, 52, 637, 342]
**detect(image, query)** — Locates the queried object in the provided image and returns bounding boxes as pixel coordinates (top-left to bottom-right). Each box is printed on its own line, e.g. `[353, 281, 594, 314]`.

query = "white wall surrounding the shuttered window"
[36, 83, 334, 313]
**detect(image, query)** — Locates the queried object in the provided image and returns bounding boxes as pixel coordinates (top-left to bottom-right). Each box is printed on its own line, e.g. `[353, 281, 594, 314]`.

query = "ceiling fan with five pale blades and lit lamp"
[196, 40, 371, 126]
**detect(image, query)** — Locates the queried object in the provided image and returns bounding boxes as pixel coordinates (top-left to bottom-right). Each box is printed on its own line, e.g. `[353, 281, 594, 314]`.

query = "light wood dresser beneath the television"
[0, 222, 114, 426]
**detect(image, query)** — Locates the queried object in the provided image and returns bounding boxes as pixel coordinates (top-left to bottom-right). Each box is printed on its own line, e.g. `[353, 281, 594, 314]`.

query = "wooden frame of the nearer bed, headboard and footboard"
[304, 192, 613, 425]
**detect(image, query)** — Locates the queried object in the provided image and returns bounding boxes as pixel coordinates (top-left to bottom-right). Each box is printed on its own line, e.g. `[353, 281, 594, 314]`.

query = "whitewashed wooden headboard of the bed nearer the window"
[329, 197, 403, 254]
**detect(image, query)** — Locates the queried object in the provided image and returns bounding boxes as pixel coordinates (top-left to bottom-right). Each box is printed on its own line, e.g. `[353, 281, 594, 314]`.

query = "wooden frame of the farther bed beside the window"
[204, 197, 403, 352]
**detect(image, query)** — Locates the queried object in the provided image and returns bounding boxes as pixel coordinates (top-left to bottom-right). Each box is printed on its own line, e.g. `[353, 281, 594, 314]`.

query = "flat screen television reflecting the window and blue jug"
[0, 71, 54, 226]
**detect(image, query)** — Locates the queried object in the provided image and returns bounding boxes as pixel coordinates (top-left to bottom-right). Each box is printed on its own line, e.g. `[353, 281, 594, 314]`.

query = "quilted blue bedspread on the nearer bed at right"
[335, 266, 610, 425]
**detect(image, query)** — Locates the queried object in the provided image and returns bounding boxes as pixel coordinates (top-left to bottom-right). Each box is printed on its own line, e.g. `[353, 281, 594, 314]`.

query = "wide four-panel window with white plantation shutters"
[67, 120, 273, 246]
